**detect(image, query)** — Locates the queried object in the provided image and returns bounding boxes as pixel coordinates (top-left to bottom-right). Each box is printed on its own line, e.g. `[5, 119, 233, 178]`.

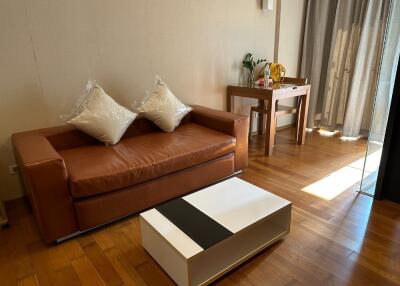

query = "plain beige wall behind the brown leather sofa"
[0, 0, 304, 200]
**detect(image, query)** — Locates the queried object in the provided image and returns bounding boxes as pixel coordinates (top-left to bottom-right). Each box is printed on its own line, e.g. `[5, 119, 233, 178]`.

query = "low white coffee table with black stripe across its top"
[140, 178, 292, 285]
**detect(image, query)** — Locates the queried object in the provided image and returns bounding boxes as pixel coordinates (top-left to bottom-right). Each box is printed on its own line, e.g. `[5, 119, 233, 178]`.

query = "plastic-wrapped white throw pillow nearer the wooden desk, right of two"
[138, 77, 192, 132]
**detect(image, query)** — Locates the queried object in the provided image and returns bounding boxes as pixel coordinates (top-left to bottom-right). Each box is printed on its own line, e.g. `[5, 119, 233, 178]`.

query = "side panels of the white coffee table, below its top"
[140, 205, 291, 286]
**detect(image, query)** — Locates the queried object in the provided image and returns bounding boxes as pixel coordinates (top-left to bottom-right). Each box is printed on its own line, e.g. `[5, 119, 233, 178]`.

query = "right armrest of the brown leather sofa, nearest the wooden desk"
[190, 105, 249, 172]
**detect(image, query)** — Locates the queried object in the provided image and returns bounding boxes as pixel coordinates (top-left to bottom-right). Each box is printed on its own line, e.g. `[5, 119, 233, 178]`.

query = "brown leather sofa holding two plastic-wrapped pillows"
[12, 106, 249, 242]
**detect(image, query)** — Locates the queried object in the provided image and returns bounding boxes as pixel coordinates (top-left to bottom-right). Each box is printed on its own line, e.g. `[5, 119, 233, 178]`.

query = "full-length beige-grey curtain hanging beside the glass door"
[301, 0, 389, 137]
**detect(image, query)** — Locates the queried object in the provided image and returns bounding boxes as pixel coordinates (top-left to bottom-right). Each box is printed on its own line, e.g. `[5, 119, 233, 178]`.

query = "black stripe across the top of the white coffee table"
[156, 198, 233, 249]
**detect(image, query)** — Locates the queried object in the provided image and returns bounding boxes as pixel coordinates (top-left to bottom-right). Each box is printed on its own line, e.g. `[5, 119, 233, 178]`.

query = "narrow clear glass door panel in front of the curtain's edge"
[360, 0, 400, 196]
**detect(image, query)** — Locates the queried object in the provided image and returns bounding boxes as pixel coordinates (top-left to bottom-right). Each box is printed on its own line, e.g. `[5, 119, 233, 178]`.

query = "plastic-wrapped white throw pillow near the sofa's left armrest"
[67, 83, 137, 145]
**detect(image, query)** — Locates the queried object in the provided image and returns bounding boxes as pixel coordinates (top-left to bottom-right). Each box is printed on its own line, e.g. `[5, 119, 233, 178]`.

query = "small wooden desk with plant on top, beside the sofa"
[227, 83, 311, 156]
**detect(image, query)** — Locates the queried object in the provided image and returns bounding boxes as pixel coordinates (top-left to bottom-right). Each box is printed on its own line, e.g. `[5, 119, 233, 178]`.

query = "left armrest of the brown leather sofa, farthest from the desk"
[12, 132, 78, 242]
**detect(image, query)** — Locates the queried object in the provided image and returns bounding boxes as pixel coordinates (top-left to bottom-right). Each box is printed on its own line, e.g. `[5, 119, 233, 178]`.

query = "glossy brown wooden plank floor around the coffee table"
[0, 130, 400, 286]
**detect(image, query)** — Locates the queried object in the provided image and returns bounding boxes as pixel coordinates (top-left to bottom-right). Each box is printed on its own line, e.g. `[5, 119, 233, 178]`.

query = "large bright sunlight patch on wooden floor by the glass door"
[302, 150, 382, 201]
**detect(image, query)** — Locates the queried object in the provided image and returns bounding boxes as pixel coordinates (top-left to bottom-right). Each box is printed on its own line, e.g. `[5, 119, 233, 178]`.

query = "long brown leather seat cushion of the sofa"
[60, 123, 236, 198]
